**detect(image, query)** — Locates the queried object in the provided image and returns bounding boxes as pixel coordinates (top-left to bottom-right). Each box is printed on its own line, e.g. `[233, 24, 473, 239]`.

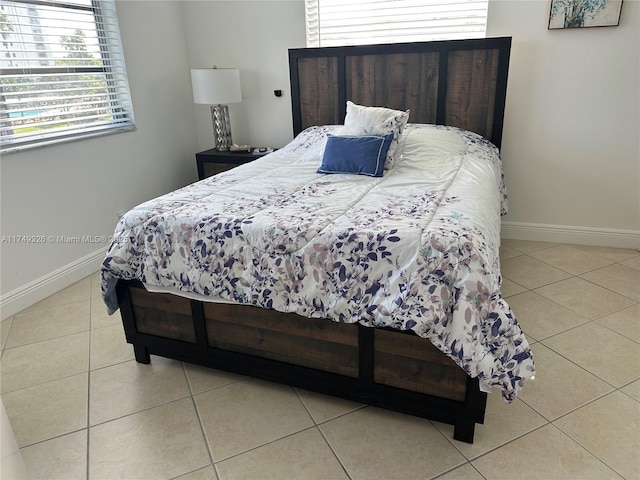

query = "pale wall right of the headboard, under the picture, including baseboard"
[487, 0, 640, 248]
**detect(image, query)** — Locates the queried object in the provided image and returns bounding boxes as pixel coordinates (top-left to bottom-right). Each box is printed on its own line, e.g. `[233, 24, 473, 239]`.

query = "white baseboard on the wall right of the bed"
[502, 222, 640, 250]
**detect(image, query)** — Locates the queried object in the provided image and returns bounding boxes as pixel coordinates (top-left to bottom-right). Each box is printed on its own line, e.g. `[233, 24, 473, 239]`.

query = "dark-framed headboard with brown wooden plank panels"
[289, 37, 511, 147]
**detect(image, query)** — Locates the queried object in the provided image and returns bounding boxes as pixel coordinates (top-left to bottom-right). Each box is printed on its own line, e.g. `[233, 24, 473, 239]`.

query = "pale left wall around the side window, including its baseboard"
[0, 1, 198, 318]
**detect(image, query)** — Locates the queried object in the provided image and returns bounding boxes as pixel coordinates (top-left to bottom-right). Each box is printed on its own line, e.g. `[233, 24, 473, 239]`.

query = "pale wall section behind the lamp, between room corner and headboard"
[182, 0, 305, 150]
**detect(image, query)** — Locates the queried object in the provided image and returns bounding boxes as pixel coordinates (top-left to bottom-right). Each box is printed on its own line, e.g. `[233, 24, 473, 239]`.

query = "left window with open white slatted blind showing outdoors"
[0, 0, 135, 153]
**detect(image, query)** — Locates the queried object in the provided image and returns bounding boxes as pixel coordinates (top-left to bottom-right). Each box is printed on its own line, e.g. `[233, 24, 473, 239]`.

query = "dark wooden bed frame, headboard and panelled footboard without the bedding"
[117, 38, 511, 442]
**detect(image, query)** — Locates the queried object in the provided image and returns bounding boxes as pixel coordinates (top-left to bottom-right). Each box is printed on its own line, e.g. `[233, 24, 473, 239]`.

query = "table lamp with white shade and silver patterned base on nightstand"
[191, 66, 242, 151]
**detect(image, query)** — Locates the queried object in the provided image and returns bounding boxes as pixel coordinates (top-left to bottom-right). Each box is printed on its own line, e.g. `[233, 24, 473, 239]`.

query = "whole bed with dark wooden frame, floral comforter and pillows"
[101, 38, 535, 442]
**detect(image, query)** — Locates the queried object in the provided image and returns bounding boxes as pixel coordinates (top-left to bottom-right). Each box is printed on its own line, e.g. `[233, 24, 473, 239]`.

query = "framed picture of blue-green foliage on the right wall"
[549, 0, 622, 30]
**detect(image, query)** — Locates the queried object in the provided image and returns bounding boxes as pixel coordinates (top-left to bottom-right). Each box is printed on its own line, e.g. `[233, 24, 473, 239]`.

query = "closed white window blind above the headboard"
[305, 0, 488, 47]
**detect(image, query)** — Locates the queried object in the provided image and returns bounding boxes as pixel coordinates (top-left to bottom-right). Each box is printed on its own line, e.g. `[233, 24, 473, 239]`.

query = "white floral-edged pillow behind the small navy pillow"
[340, 101, 410, 170]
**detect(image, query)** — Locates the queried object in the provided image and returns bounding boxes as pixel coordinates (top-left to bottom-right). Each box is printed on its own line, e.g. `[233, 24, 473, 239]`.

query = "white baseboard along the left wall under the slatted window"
[0, 249, 107, 320]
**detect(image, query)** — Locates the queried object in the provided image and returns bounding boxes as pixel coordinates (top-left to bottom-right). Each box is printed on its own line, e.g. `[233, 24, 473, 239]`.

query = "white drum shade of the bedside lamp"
[191, 68, 242, 105]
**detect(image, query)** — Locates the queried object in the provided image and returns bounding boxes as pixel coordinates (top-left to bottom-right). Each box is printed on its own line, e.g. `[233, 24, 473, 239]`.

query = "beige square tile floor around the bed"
[1, 240, 640, 480]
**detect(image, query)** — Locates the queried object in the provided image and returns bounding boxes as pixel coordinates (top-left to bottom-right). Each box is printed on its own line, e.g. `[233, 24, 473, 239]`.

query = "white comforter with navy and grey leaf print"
[101, 124, 534, 402]
